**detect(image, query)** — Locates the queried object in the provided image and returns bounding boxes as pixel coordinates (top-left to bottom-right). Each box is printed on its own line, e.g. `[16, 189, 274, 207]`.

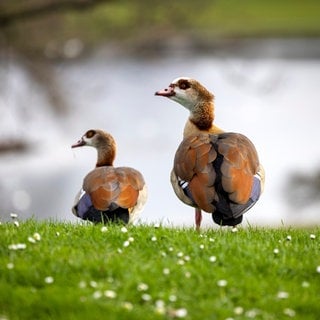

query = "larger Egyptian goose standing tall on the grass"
[155, 77, 264, 229]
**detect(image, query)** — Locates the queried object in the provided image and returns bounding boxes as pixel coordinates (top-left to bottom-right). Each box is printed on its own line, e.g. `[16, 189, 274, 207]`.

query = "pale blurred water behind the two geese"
[0, 43, 320, 225]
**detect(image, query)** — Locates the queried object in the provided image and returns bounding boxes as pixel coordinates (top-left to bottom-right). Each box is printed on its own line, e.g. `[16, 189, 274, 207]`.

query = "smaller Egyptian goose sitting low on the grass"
[71, 130, 147, 223]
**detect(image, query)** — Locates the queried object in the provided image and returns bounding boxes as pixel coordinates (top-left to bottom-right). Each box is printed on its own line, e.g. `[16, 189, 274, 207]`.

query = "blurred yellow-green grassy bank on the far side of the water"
[65, 0, 320, 42]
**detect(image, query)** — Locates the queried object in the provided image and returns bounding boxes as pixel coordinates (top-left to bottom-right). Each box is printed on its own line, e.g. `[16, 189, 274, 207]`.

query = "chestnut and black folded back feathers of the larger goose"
[173, 133, 259, 213]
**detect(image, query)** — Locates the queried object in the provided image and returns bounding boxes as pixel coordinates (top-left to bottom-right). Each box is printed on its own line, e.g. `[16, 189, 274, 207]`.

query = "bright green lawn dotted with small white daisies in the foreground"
[0, 220, 320, 320]
